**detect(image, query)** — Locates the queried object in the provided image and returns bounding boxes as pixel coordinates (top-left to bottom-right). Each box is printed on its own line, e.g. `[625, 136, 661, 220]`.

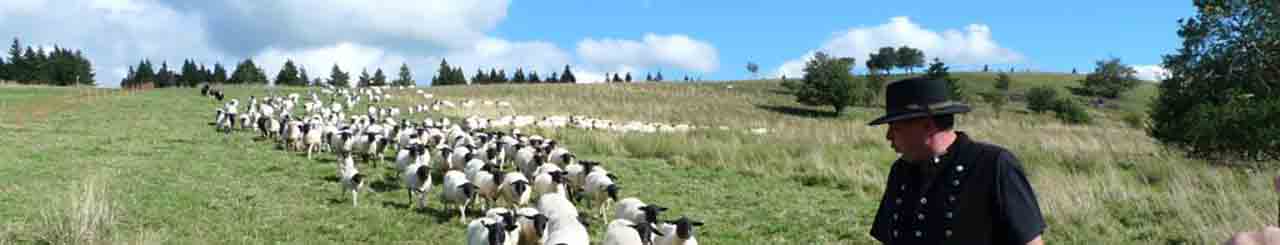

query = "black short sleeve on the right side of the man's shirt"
[995, 150, 1048, 244]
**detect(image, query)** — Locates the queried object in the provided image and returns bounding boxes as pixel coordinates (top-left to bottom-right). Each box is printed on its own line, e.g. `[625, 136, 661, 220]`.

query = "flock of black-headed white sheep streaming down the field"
[209, 87, 703, 245]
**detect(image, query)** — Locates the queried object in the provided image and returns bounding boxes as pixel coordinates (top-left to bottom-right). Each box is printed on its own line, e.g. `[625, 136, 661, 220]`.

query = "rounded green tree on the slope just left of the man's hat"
[788, 51, 860, 114]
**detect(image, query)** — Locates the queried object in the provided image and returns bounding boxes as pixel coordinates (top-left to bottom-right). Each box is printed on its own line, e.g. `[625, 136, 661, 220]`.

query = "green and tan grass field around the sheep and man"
[0, 73, 1275, 244]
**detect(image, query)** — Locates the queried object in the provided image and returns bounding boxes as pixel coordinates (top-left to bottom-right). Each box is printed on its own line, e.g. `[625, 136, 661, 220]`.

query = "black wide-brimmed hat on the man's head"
[868, 77, 969, 126]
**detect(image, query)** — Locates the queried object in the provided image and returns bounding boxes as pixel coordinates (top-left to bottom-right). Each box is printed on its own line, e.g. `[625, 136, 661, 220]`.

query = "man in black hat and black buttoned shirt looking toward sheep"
[870, 78, 1047, 244]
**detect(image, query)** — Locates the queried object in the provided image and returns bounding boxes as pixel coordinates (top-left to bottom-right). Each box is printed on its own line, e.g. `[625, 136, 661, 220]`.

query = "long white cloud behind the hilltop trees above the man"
[774, 17, 1024, 77]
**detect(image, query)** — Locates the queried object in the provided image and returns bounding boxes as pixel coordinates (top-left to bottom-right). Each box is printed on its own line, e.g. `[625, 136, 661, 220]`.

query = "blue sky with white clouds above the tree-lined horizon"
[0, 0, 1194, 87]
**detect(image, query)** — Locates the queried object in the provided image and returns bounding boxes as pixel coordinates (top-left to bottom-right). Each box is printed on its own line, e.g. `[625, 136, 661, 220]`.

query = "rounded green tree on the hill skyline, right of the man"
[1075, 58, 1142, 99]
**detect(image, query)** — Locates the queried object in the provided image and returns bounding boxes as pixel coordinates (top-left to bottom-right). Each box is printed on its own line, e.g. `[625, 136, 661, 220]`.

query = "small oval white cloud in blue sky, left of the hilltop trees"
[577, 33, 719, 72]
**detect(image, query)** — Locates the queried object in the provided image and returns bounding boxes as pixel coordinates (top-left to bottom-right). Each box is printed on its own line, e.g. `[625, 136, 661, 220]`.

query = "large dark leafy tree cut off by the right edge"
[1148, 0, 1280, 160]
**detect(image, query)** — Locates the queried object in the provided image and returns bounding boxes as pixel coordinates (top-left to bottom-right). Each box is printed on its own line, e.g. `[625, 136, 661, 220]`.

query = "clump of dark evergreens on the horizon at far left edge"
[0, 37, 97, 86]
